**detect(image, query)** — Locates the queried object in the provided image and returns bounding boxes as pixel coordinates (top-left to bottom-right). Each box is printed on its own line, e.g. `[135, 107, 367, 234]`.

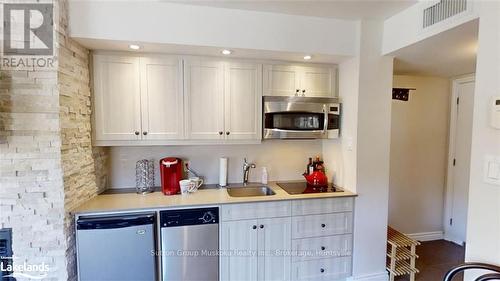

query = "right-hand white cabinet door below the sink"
[258, 217, 292, 281]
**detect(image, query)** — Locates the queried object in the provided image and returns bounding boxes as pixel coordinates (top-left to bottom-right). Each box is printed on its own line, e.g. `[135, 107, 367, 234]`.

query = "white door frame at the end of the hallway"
[443, 73, 476, 245]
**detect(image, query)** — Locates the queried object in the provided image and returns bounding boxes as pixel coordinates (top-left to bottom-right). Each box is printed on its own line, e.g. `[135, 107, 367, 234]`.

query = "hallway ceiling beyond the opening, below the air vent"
[391, 20, 479, 77]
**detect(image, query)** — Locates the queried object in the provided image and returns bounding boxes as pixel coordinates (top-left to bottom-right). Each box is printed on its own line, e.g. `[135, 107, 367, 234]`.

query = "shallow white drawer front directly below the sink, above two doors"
[221, 201, 291, 221]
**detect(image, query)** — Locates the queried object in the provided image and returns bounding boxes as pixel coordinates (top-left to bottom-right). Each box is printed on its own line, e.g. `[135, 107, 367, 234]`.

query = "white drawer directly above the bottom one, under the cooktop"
[292, 234, 352, 262]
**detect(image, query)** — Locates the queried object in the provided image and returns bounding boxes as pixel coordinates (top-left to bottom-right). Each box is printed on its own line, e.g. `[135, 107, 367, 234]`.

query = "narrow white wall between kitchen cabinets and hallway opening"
[353, 21, 393, 280]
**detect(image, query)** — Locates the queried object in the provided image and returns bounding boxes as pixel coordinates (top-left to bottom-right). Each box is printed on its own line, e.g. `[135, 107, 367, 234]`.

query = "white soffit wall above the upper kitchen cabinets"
[69, 0, 357, 56]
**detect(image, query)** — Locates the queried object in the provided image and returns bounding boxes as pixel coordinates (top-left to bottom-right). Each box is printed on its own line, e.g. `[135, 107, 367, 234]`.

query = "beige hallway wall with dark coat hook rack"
[389, 75, 450, 234]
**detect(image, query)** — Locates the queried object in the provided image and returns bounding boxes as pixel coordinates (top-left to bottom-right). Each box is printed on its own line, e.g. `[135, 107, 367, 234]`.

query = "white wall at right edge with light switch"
[465, 1, 500, 280]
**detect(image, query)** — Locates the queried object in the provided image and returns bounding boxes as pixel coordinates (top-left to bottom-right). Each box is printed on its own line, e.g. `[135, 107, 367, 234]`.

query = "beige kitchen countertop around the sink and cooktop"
[73, 182, 357, 214]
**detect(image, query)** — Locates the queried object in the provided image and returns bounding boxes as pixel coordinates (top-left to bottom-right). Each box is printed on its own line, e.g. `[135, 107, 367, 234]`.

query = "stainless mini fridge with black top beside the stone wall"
[76, 213, 157, 281]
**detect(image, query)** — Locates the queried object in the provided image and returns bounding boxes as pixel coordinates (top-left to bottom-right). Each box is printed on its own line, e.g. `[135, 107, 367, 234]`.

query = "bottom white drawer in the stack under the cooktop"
[292, 257, 351, 281]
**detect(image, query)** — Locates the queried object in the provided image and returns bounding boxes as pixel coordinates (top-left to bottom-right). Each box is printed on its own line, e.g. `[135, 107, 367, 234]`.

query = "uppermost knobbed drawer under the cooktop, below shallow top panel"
[292, 212, 352, 239]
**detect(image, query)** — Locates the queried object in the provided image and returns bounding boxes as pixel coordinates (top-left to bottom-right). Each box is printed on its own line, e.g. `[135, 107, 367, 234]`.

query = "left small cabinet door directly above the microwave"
[264, 65, 300, 96]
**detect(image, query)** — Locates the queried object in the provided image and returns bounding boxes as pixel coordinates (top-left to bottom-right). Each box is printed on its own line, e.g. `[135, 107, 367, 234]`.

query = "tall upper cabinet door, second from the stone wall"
[141, 56, 184, 140]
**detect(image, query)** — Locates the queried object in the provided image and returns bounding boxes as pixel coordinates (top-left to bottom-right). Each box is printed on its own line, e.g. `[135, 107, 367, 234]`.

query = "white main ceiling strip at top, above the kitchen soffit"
[170, 0, 417, 20]
